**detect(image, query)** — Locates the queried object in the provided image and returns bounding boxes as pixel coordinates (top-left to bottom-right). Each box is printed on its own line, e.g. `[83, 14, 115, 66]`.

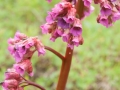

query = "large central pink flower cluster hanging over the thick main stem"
[41, 1, 83, 48]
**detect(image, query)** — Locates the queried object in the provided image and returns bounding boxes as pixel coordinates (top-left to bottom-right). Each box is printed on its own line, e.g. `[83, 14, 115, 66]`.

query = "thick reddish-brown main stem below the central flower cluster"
[56, 47, 73, 90]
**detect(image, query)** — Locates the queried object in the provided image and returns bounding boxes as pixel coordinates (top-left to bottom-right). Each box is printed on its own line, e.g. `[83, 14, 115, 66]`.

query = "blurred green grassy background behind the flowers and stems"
[0, 0, 120, 90]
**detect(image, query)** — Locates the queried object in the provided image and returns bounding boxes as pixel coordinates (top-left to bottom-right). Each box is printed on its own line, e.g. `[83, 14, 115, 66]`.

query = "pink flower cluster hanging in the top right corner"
[94, 0, 120, 27]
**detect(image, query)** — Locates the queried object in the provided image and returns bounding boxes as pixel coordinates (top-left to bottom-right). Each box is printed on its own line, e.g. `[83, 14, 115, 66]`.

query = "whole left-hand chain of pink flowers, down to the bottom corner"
[2, 32, 45, 90]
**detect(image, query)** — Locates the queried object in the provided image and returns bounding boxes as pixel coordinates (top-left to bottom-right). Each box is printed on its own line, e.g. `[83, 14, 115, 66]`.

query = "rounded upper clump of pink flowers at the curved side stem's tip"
[8, 32, 45, 62]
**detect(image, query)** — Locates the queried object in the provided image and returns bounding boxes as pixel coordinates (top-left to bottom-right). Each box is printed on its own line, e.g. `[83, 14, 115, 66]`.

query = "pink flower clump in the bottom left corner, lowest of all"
[2, 68, 23, 90]
